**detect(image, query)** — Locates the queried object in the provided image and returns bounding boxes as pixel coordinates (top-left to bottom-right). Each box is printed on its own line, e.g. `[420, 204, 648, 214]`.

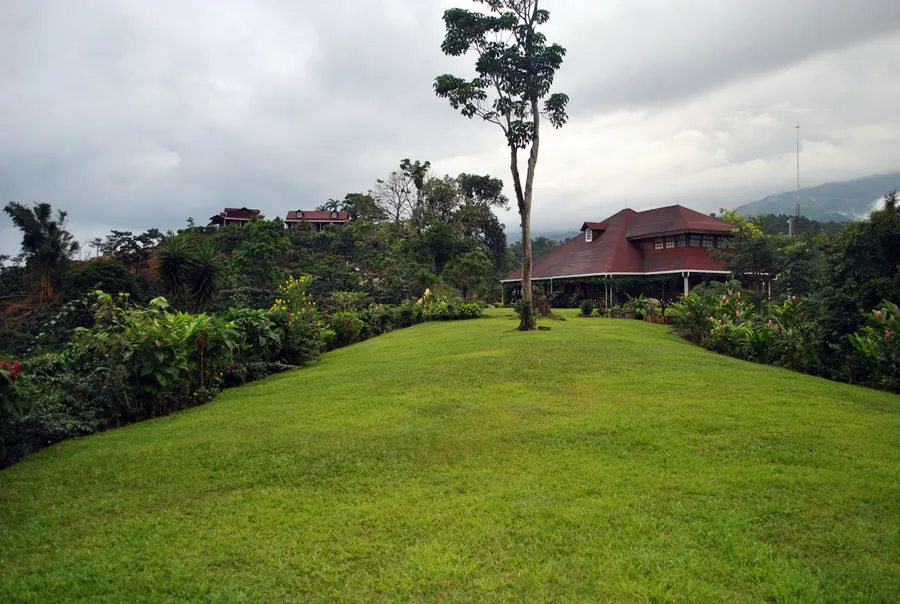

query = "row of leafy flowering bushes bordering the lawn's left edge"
[0, 284, 482, 464]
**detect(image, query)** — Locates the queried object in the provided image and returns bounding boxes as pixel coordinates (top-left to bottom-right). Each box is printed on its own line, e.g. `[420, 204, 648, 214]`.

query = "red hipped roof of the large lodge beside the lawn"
[504, 206, 732, 281]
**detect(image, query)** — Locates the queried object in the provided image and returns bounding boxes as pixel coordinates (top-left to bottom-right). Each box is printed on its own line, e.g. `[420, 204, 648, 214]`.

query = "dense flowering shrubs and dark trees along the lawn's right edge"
[671, 192, 900, 392]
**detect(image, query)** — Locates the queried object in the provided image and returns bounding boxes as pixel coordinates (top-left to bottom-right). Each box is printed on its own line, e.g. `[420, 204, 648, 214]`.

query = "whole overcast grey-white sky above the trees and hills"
[0, 0, 900, 253]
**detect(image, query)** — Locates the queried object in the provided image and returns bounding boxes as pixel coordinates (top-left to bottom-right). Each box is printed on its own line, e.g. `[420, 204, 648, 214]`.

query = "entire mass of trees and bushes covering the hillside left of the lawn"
[0, 160, 513, 463]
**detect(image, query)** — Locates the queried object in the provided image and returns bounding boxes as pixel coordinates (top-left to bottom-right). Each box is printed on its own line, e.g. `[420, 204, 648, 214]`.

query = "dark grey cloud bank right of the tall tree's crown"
[554, 0, 900, 112]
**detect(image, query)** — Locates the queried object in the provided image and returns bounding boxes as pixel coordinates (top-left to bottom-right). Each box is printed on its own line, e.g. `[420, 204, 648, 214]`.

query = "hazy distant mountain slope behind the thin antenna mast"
[737, 172, 900, 221]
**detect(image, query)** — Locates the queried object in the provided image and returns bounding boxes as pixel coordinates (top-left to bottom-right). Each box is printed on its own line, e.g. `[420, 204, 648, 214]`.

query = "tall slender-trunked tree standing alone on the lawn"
[434, 0, 569, 330]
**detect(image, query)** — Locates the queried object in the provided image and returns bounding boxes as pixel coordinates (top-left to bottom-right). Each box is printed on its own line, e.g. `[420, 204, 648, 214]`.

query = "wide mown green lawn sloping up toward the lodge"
[0, 310, 900, 602]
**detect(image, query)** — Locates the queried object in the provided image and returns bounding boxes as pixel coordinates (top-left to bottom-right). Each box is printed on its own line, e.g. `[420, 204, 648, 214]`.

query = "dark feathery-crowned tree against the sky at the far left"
[3, 201, 79, 304]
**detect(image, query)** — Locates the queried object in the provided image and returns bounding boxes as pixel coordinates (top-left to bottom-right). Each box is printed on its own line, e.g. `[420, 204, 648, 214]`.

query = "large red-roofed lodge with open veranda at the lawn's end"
[502, 205, 732, 304]
